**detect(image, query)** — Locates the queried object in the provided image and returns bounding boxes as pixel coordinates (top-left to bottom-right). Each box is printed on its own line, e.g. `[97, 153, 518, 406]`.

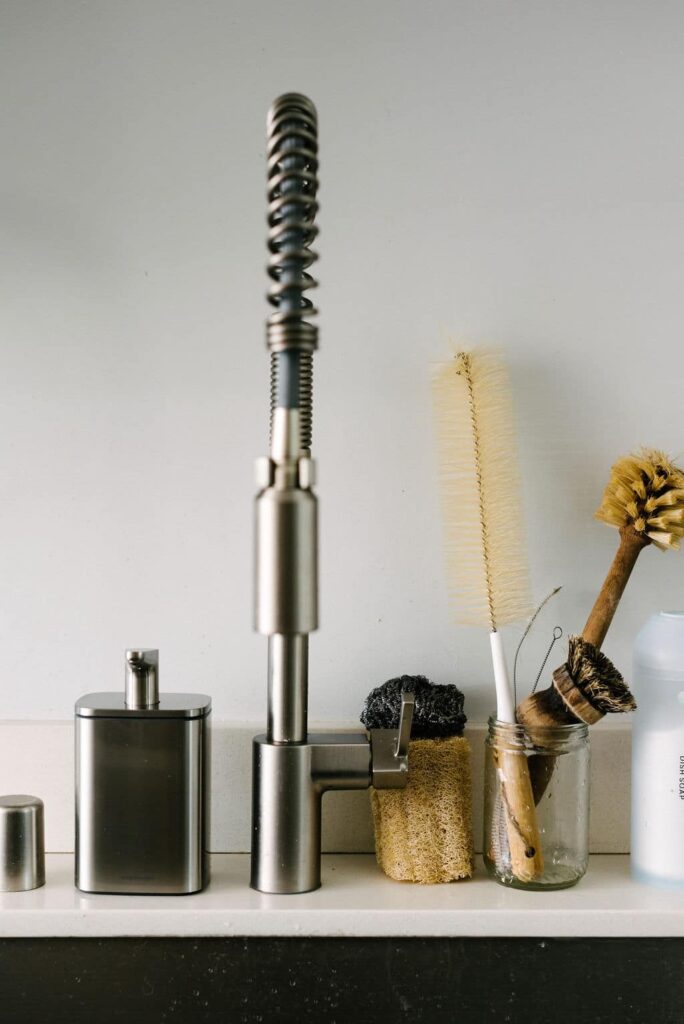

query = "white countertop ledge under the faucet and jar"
[0, 854, 684, 938]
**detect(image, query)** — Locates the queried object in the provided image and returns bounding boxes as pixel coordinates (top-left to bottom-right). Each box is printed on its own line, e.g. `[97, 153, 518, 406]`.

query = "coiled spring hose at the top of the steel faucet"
[266, 92, 318, 452]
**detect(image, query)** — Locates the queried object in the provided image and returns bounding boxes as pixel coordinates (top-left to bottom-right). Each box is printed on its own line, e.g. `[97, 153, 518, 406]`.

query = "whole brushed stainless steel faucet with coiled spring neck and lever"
[251, 93, 414, 893]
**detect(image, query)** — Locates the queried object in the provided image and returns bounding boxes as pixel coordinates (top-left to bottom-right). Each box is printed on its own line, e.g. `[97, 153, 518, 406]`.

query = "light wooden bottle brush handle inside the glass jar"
[494, 750, 544, 882]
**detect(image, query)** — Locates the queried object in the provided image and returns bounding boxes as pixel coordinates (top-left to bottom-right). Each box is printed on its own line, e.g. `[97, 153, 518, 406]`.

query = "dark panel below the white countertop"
[0, 937, 684, 1024]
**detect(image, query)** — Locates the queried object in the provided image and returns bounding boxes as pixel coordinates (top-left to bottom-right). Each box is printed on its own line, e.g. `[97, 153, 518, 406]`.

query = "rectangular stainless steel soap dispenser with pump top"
[76, 649, 211, 895]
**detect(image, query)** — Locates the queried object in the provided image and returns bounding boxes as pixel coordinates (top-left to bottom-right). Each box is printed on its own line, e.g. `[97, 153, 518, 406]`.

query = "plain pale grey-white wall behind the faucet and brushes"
[0, 0, 684, 721]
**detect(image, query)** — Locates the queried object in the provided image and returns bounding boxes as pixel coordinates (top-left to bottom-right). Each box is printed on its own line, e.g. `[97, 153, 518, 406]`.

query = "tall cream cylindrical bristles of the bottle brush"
[433, 351, 531, 630]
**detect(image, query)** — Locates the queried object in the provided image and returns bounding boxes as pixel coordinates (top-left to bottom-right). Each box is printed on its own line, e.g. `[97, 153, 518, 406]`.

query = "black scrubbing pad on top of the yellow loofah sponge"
[361, 676, 467, 739]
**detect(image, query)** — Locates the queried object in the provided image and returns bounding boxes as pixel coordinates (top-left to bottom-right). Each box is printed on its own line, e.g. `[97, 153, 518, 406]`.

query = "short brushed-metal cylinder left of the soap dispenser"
[0, 795, 45, 893]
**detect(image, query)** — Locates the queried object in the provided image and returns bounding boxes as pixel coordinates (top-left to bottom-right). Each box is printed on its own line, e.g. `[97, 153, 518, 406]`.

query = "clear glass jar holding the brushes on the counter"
[483, 718, 589, 890]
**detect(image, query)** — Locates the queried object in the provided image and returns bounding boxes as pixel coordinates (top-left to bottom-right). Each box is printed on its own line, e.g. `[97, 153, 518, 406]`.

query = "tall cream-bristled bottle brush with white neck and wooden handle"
[433, 351, 544, 882]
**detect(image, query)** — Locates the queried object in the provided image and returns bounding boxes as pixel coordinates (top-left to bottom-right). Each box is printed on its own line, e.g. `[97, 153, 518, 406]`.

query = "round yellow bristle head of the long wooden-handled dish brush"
[596, 449, 684, 550]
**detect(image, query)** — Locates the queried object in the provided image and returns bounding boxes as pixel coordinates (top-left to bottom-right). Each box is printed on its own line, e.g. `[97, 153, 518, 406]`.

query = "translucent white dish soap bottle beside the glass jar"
[632, 611, 684, 886]
